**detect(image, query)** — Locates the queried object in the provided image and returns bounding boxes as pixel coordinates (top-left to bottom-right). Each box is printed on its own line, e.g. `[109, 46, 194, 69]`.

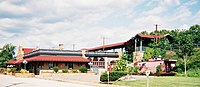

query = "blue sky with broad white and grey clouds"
[0, 0, 200, 50]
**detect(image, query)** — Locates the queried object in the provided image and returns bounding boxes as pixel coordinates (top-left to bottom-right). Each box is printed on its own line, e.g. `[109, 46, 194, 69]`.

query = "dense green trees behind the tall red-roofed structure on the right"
[125, 24, 200, 76]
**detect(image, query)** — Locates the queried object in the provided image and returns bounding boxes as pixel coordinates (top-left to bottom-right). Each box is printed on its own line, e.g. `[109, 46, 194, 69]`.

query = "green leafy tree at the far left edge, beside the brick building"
[0, 44, 15, 67]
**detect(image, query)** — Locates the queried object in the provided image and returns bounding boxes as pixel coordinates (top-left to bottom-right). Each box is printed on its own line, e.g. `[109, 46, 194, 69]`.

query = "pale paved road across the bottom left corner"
[0, 75, 99, 87]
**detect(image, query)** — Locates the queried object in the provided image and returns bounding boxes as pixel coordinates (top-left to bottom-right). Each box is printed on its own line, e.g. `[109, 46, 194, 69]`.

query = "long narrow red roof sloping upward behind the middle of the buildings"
[83, 42, 125, 50]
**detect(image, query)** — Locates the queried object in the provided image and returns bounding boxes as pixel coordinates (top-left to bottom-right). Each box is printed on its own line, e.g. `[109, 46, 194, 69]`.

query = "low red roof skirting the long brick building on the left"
[6, 56, 90, 64]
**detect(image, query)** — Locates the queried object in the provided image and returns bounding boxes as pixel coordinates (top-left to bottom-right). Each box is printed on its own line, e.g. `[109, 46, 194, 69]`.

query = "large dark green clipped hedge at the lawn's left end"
[100, 71, 128, 82]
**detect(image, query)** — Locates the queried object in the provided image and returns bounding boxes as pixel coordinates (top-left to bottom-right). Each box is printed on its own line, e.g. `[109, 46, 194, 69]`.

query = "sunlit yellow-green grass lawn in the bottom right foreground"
[113, 77, 200, 87]
